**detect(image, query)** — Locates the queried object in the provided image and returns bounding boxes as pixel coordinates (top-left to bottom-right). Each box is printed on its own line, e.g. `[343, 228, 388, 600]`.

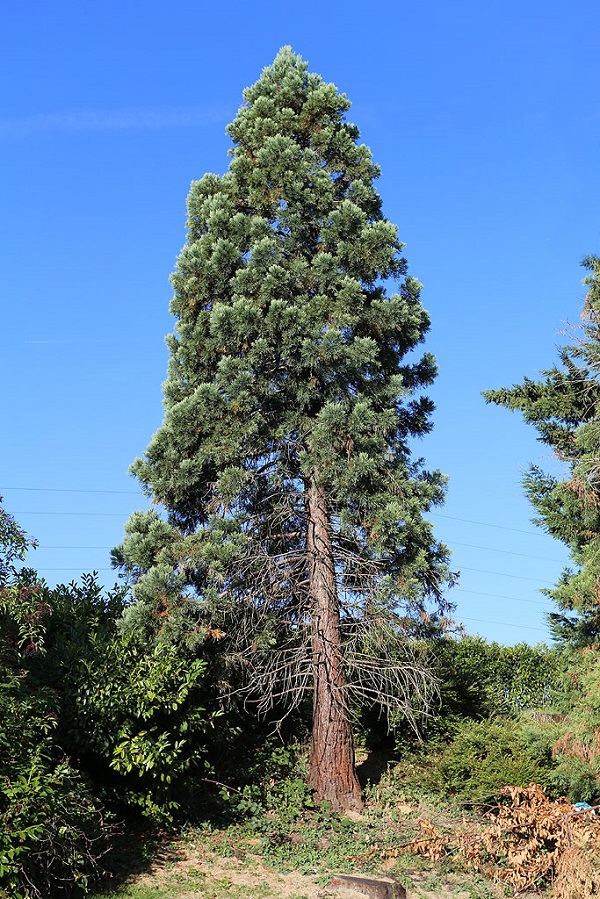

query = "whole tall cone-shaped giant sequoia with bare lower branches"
[115, 48, 449, 810]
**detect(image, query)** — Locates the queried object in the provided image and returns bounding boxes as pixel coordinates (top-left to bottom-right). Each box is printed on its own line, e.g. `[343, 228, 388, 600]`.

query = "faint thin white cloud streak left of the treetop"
[0, 107, 233, 140]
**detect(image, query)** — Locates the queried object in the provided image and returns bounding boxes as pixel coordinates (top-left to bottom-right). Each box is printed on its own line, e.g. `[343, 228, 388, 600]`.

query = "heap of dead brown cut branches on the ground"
[407, 784, 600, 899]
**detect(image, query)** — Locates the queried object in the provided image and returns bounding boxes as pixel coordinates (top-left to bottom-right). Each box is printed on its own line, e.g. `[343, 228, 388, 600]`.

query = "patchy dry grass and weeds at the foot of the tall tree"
[91, 782, 504, 899]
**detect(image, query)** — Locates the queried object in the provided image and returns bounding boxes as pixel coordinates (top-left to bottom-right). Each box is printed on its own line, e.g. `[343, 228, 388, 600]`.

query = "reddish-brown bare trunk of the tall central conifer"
[307, 475, 362, 812]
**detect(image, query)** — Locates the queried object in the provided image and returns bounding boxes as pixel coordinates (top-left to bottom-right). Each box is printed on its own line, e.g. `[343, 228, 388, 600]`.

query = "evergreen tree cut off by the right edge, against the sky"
[484, 256, 600, 646]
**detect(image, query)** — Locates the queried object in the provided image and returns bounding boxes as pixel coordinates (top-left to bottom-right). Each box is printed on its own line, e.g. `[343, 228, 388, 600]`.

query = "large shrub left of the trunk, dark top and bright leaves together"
[37, 576, 215, 820]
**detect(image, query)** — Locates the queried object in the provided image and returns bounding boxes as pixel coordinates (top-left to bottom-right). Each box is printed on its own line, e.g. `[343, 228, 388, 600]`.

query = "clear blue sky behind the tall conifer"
[0, 0, 600, 643]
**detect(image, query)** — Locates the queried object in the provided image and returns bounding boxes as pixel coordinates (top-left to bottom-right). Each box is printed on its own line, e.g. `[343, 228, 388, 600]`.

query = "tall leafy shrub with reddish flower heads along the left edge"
[0, 506, 110, 899]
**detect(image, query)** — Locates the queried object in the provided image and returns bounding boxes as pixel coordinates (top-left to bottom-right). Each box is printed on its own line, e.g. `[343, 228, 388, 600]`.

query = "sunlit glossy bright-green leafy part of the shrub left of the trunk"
[77, 639, 210, 818]
